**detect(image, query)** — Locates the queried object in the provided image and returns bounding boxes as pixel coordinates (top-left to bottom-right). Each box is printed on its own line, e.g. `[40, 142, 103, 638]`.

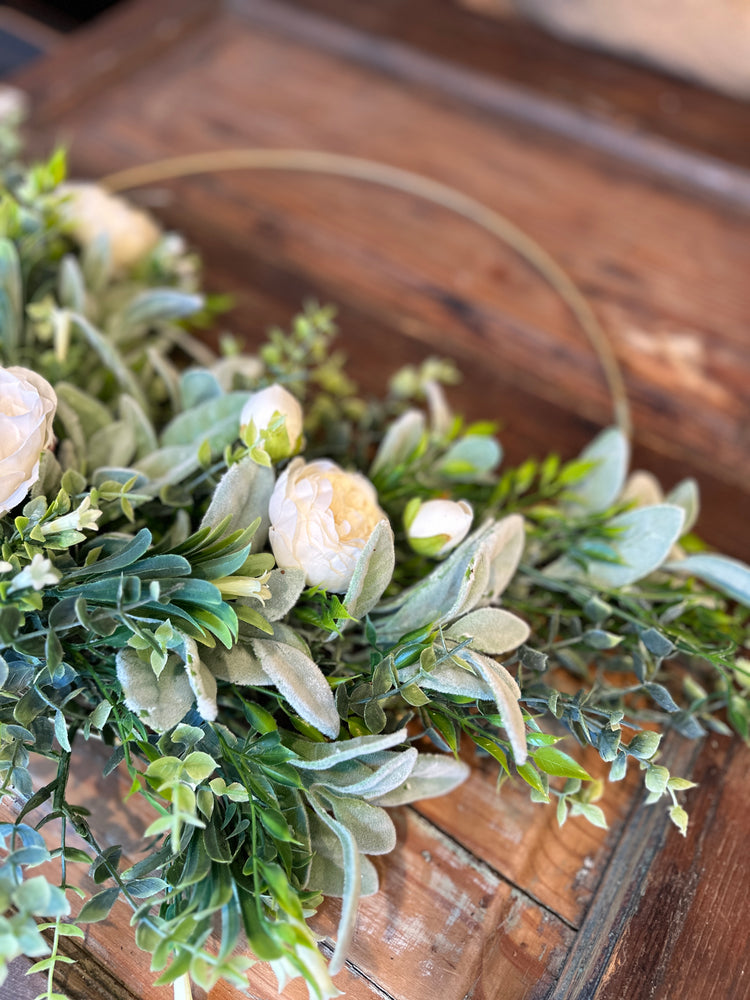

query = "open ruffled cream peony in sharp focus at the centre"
[268, 458, 385, 594]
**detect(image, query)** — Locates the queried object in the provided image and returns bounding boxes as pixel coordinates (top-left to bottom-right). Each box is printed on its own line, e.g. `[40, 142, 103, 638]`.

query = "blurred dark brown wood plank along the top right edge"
[284, 0, 750, 168]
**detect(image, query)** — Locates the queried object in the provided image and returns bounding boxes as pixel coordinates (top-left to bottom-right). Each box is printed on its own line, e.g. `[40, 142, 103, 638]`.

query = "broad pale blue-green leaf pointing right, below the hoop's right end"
[544, 504, 685, 590]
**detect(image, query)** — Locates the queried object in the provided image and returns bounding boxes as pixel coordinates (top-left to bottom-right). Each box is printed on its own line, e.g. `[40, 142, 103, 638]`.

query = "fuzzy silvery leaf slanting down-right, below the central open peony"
[251, 639, 341, 738]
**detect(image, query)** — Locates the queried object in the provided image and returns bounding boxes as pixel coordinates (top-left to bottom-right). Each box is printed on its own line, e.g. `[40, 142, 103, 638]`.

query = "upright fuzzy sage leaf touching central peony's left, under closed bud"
[201, 454, 276, 552]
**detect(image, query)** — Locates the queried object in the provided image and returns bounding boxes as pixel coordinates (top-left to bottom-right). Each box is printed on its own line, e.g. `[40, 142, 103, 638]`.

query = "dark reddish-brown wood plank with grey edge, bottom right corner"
[553, 737, 750, 1000]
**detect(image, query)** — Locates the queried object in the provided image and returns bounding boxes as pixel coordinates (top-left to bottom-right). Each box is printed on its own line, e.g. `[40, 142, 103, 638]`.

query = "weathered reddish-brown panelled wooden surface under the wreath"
[6, 0, 750, 1000]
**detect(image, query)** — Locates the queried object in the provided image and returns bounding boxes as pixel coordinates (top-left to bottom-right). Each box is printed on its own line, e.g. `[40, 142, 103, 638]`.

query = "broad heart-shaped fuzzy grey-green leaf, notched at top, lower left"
[115, 646, 193, 733]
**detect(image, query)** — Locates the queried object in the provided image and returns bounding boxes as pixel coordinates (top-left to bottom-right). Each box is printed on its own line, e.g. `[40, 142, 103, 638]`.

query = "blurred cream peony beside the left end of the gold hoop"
[58, 182, 162, 270]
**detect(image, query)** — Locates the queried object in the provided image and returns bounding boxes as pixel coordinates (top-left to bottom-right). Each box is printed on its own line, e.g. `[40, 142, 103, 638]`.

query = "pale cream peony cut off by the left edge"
[0, 368, 57, 516]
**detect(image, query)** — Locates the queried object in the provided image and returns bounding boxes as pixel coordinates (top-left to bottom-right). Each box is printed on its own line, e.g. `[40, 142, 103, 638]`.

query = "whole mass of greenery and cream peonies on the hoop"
[0, 133, 750, 1000]
